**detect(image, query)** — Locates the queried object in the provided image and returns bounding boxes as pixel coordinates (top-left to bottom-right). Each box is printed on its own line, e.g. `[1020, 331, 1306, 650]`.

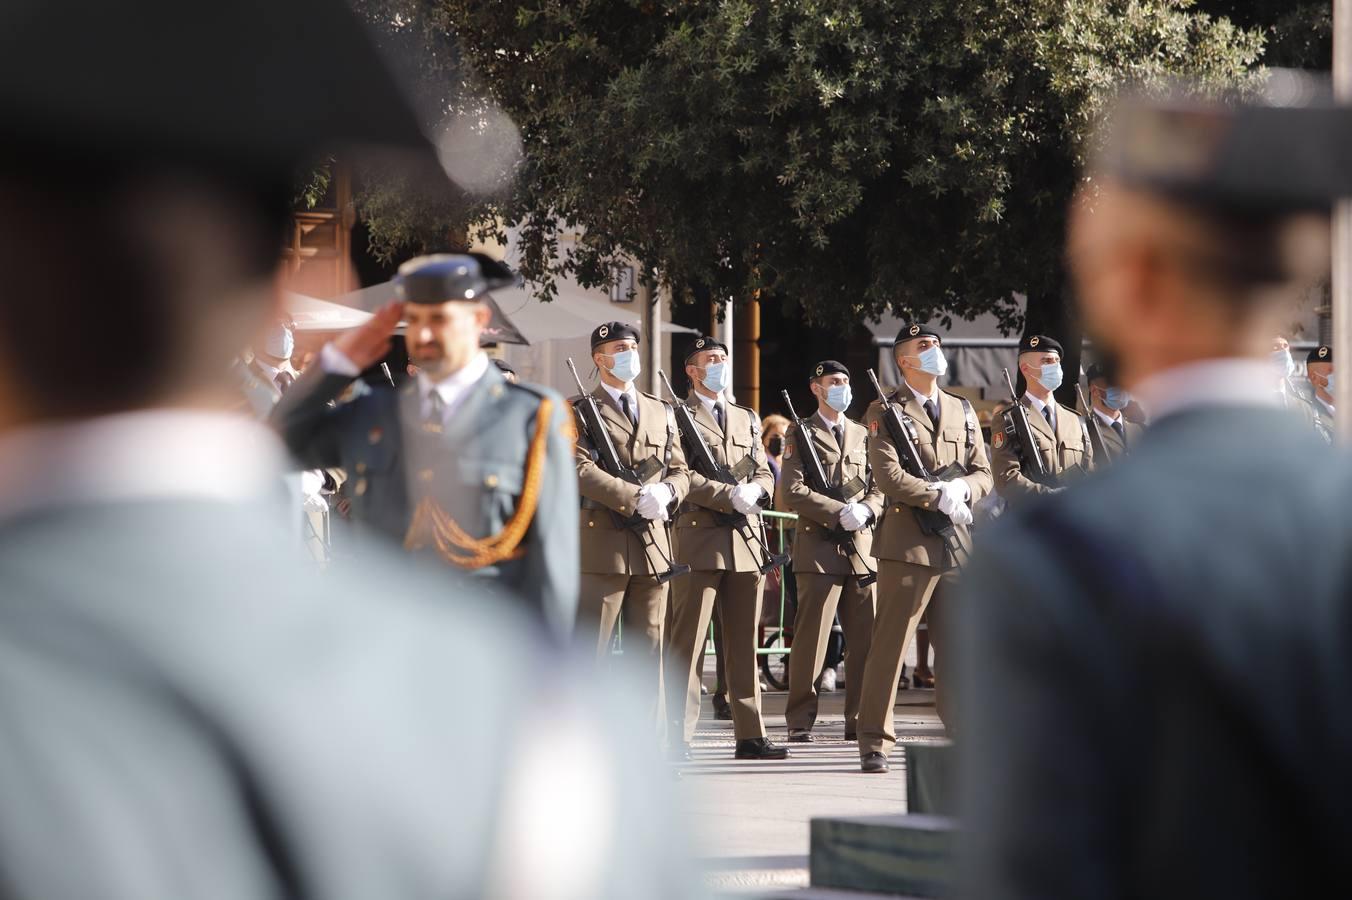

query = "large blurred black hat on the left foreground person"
[0, 0, 432, 181]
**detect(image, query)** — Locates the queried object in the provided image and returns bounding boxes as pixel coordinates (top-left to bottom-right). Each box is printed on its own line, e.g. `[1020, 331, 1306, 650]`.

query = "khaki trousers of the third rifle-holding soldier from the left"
[784, 572, 873, 734]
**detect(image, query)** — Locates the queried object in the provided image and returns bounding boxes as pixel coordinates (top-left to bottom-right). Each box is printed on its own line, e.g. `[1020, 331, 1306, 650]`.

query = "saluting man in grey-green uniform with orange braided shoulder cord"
[272, 254, 579, 636]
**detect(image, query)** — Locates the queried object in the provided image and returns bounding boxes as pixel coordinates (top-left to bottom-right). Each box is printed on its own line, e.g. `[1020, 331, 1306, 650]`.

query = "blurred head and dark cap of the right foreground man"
[1068, 73, 1352, 386]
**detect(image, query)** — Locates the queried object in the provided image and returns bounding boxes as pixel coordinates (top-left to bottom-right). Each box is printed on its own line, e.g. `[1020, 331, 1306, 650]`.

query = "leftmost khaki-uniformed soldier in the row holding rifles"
[573, 322, 690, 724]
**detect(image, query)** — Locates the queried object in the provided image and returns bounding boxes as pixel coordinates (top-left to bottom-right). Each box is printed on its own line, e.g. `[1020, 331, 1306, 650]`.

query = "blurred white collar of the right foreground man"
[1132, 358, 1282, 422]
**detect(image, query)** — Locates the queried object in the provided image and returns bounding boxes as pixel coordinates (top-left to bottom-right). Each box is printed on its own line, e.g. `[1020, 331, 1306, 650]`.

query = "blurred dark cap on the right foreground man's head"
[1099, 78, 1352, 214]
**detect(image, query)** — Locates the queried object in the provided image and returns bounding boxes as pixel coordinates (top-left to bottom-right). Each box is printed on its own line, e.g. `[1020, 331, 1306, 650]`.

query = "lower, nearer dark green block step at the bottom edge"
[808, 815, 955, 897]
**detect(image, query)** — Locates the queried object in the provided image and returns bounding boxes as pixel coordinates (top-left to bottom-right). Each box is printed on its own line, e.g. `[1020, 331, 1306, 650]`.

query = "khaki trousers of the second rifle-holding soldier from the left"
[667, 572, 765, 743]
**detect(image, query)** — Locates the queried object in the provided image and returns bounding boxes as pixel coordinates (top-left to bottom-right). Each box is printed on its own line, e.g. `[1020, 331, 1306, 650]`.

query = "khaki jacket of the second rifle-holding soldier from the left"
[676, 392, 776, 572]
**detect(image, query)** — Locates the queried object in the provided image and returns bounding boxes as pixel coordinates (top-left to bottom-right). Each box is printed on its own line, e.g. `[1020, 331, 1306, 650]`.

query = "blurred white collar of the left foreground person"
[0, 409, 285, 519]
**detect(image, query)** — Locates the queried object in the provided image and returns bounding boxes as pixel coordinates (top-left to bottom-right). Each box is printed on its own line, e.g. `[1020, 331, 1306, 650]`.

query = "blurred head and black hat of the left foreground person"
[0, 0, 434, 430]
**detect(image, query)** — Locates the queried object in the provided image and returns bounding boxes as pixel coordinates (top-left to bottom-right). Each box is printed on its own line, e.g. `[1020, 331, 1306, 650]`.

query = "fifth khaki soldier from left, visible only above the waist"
[991, 334, 1094, 501]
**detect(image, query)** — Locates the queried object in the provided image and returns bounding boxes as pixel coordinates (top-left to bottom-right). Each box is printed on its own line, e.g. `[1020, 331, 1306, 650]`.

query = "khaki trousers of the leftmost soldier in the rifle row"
[577, 572, 668, 726]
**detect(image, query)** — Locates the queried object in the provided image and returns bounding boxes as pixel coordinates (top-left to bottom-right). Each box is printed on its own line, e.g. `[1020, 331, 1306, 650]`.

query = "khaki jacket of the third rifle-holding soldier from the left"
[779, 414, 887, 574]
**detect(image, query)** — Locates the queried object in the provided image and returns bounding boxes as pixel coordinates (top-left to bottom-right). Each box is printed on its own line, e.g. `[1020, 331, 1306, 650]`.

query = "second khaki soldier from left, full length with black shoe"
[668, 338, 788, 759]
